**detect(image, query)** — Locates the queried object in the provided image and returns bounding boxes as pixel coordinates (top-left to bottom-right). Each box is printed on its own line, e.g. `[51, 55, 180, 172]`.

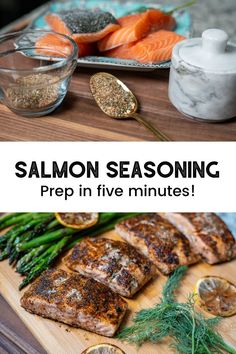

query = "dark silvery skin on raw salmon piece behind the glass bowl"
[58, 9, 118, 33]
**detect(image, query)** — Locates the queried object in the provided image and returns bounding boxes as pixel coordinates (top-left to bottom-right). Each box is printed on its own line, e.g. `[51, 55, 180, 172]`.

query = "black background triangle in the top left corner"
[0, 0, 46, 28]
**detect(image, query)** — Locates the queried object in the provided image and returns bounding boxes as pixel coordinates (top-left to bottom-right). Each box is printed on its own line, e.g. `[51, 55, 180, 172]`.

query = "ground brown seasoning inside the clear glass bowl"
[6, 74, 60, 109]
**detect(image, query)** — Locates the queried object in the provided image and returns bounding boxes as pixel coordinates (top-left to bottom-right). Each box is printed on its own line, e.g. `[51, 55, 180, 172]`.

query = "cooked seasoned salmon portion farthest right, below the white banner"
[161, 213, 235, 264]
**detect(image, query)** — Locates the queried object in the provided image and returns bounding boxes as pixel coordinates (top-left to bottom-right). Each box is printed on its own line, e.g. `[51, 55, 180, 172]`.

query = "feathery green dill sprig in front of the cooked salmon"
[117, 266, 236, 354]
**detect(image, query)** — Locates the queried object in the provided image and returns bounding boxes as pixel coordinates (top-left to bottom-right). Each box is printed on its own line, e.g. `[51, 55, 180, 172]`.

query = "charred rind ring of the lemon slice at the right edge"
[193, 275, 236, 317]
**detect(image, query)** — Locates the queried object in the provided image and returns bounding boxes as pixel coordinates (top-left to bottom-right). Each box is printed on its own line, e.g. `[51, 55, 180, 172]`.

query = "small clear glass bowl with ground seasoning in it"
[0, 30, 78, 117]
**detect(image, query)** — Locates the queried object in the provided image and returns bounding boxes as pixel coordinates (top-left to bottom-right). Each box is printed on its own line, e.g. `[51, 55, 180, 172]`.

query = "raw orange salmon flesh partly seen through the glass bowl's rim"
[36, 33, 95, 57]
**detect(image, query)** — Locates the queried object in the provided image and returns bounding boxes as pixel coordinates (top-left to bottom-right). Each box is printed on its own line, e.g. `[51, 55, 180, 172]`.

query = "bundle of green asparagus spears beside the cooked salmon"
[0, 213, 134, 290]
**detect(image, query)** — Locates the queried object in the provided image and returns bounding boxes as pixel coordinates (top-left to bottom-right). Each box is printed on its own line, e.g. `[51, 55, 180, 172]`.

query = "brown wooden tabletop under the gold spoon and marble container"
[0, 68, 236, 141]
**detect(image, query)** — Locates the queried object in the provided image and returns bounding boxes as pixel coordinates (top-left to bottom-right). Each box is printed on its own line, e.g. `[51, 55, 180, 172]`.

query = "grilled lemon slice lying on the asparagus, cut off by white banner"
[55, 213, 99, 230]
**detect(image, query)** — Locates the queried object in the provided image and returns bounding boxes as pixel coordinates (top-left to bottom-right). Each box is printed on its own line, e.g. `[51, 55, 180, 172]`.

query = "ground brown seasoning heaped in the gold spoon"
[90, 74, 137, 118]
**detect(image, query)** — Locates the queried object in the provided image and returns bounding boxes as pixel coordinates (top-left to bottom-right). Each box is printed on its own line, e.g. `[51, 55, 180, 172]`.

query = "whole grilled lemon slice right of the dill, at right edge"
[196, 276, 236, 317]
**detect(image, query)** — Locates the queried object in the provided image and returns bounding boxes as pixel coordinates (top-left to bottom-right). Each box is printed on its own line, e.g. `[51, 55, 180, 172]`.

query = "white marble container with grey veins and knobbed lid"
[169, 29, 236, 122]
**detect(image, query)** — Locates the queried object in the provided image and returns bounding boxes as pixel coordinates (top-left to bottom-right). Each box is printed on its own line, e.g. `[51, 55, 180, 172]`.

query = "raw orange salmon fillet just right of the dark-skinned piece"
[98, 9, 176, 52]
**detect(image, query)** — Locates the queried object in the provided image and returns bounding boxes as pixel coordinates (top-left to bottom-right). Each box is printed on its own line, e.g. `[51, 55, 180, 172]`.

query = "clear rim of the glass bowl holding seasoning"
[0, 29, 78, 73]
